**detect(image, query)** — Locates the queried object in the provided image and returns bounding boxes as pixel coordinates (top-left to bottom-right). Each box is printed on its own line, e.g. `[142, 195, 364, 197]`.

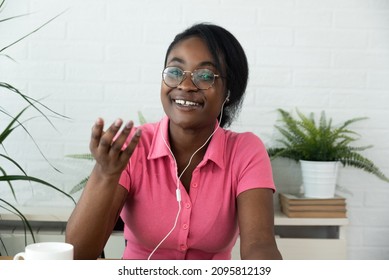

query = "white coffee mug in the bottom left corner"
[14, 242, 73, 260]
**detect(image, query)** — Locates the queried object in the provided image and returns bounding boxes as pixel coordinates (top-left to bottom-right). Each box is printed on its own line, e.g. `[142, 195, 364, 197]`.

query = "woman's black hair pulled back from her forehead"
[165, 23, 249, 127]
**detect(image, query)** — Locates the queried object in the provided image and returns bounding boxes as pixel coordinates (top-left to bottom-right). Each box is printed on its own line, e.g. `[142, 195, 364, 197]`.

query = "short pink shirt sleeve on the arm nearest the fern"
[232, 133, 276, 196]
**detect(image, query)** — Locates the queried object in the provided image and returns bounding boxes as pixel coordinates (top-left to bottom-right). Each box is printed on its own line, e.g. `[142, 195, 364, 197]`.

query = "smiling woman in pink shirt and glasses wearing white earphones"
[66, 24, 281, 259]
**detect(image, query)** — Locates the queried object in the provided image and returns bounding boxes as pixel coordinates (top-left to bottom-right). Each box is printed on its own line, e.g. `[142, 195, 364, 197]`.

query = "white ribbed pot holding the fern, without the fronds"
[300, 160, 339, 198]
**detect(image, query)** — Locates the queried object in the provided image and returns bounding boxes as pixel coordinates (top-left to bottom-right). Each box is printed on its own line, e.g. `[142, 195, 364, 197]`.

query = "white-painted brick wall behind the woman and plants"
[0, 0, 389, 259]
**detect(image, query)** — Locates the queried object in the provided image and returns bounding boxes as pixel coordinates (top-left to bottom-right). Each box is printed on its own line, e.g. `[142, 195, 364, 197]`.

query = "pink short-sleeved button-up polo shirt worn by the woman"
[119, 117, 275, 260]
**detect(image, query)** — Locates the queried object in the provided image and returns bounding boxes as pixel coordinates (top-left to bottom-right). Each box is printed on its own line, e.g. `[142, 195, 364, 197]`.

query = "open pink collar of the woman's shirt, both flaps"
[148, 116, 226, 169]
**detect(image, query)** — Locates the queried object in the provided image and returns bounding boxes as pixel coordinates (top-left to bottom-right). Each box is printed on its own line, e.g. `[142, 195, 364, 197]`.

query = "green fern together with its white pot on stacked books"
[268, 109, 389, 198]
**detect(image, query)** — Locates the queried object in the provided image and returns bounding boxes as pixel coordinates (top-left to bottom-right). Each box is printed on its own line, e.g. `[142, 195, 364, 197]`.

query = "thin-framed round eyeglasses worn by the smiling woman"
[162, 66, 220, 90]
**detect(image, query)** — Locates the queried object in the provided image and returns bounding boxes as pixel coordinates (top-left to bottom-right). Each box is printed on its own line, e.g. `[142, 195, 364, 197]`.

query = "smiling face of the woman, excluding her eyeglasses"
[161, 37, 226, 132]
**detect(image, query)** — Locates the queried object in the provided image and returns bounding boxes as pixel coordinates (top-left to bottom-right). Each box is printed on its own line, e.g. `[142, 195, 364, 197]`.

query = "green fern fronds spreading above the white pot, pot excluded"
[268, 109, 389, 182]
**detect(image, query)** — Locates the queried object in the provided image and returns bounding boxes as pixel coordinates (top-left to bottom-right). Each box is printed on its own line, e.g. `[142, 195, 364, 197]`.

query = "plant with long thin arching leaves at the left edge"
[0, 0, 75, 252]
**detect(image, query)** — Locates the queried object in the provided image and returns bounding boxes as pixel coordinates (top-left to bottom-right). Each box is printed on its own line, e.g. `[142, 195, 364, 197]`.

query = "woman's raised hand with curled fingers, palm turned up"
[89, 118, 141, 176]
